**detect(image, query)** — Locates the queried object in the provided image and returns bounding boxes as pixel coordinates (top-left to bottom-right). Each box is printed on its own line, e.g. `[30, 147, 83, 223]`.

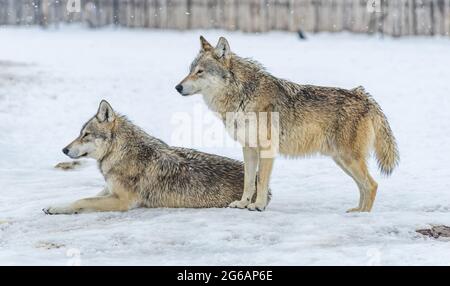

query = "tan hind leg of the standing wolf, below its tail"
[333, 157, 378, 212]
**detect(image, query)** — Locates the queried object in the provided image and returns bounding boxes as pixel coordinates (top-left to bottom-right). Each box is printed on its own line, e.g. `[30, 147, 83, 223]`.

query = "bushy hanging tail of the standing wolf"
[373, 106, 400, 176]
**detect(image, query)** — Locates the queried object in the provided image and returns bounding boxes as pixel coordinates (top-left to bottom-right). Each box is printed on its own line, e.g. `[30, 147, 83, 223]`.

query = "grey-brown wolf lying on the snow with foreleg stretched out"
[43, 100, 260, 214]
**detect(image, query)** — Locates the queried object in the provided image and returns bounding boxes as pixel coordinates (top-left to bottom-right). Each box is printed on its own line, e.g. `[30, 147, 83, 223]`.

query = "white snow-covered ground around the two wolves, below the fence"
[0, 28, 450, 265]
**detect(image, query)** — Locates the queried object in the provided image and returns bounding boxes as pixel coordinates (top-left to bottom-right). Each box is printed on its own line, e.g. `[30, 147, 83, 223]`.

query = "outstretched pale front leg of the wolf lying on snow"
[43, 195, 130, 214]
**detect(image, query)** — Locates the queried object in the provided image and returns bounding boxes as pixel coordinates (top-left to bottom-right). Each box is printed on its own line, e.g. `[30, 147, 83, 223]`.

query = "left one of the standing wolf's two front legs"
[229, 147, 258, 209]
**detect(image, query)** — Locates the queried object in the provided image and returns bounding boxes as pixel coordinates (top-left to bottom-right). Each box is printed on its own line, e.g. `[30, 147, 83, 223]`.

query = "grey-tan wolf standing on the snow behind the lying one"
[176, 37, 399, 212]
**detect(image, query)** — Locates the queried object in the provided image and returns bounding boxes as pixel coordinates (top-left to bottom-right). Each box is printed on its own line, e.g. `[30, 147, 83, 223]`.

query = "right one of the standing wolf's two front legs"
[247, 158, 274, 211]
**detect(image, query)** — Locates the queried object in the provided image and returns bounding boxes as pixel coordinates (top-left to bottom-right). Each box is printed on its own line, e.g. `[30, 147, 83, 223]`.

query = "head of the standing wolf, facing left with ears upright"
[175, 36, 232, 96]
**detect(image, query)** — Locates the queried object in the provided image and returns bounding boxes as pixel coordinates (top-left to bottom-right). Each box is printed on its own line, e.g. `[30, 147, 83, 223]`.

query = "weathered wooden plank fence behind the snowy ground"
[0, 0, 450, 36]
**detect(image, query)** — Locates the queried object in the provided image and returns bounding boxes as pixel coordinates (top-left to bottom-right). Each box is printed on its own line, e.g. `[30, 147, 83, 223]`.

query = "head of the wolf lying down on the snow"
[62, 100, 117, 160]
